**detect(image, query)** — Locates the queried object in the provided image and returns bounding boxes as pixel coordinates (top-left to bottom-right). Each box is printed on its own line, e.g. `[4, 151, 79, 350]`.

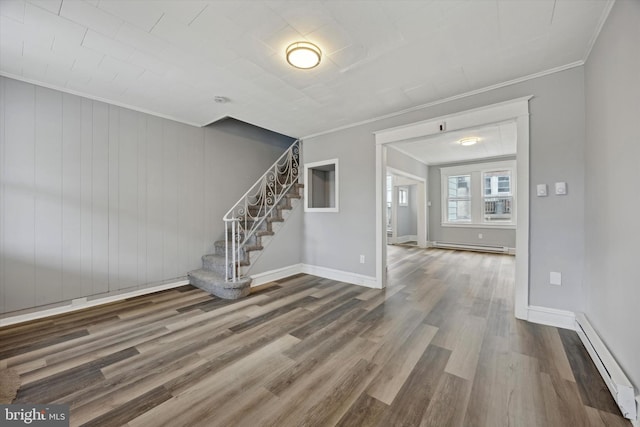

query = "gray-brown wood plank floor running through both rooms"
[0, 246, 630, 427]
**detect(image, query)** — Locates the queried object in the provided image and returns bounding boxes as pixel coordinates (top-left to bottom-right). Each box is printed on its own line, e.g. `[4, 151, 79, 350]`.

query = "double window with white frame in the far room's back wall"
[440, 160, 515, 227]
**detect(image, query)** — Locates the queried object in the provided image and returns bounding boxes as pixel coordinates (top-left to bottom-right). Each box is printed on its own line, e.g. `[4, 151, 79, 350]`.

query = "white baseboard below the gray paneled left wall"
[0, 280, 189, 326]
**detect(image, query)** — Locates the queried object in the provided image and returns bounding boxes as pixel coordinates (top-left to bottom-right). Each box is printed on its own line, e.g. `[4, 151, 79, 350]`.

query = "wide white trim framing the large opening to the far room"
[374, 96, 533, 319]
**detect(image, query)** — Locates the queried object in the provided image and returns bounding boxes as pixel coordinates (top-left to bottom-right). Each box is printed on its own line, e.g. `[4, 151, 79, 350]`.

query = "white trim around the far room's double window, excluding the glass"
[440, 160, 517, 229]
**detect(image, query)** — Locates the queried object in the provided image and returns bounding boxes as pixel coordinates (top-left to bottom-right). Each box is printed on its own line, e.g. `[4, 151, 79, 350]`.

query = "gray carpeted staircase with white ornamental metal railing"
[188, 141, 303, 299]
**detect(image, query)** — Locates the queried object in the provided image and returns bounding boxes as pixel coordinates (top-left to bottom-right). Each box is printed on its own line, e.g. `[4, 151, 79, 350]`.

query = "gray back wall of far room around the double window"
[428, 157, 516, 248]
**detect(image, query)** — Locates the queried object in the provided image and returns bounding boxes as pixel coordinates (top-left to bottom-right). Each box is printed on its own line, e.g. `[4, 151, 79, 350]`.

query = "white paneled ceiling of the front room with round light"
[0, 0, 611, 137]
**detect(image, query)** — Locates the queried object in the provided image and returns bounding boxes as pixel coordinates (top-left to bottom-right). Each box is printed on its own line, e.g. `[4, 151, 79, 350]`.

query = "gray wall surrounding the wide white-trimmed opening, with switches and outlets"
[303, 67, 585, 310]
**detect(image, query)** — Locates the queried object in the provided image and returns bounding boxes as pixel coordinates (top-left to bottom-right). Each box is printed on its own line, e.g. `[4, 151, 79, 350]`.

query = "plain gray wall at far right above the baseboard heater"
[585, 0, 640, 390]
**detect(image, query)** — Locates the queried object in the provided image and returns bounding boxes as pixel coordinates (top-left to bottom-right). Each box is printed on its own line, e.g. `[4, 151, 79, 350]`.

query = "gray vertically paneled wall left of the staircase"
[0, 78, 291, 312]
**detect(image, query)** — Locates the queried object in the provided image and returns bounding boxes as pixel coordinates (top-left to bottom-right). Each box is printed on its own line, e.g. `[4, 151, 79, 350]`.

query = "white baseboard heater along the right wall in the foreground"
[576, 313, 637, 420]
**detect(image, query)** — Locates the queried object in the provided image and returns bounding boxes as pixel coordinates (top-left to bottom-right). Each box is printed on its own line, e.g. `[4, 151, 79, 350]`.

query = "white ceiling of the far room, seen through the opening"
[392, 122, 517, 165]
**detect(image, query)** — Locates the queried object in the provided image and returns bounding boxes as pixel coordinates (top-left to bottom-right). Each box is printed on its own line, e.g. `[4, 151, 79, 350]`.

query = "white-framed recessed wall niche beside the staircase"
[304, 159, 339, 212]
